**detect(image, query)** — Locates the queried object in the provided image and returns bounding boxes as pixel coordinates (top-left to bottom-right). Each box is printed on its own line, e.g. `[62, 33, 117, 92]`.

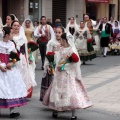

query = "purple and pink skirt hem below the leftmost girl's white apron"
[0, 98, 27, 108]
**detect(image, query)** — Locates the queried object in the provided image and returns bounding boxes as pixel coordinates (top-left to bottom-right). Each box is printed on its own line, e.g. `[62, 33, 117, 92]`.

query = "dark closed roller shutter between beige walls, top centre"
[52, 0, 67, 27]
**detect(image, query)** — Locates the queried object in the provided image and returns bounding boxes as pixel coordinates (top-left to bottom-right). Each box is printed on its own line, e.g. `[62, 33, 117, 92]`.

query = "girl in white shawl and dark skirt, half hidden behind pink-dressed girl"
[40, 26, 64, 101]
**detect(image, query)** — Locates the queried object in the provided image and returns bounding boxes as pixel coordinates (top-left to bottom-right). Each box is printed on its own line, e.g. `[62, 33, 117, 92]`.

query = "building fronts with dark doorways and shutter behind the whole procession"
[0, 0, 120, 26]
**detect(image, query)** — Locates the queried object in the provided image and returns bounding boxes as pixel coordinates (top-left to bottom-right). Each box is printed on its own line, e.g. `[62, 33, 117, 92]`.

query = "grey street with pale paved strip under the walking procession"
[0, 56, 120, 120]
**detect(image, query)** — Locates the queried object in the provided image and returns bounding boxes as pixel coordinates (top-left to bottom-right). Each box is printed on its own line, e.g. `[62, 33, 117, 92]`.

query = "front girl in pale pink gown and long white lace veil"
[43, 33, 92, 120]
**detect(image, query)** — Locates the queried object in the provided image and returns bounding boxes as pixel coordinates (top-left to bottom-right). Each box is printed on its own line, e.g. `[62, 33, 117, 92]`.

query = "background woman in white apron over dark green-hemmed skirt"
[74, 21, 96, 64]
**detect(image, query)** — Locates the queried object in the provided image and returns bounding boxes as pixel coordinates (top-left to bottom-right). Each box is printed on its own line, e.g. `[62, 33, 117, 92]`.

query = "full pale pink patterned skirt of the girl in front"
[42, 71, 92, 111]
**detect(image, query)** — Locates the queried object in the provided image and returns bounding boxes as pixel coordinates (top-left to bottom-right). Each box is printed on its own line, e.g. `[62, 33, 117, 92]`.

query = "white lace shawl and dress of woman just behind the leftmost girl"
[13, 34, 36, 90]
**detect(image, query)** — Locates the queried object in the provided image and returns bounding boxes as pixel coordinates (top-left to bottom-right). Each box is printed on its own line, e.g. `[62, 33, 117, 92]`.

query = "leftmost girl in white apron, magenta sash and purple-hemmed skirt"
[0, 27, 27, 118]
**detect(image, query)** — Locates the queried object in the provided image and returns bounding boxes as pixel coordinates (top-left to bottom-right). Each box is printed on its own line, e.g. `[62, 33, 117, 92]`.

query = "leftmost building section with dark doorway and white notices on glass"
[0, 0, 42, 24]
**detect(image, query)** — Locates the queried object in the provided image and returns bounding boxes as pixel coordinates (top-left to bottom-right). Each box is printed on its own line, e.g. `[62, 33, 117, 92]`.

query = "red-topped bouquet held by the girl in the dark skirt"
[46, 52, 55, 74]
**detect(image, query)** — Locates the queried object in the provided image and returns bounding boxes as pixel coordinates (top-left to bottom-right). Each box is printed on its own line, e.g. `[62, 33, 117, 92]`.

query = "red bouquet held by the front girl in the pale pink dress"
[60, 53, 79, 70]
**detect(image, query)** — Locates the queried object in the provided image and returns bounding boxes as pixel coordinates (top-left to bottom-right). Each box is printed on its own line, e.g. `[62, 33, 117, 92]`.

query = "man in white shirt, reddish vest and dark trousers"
[34, 16, 55, 70]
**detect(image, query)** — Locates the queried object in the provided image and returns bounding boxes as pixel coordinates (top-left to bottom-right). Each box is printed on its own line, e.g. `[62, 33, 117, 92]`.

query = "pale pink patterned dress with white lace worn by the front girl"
[43, 47, 92, 111]
